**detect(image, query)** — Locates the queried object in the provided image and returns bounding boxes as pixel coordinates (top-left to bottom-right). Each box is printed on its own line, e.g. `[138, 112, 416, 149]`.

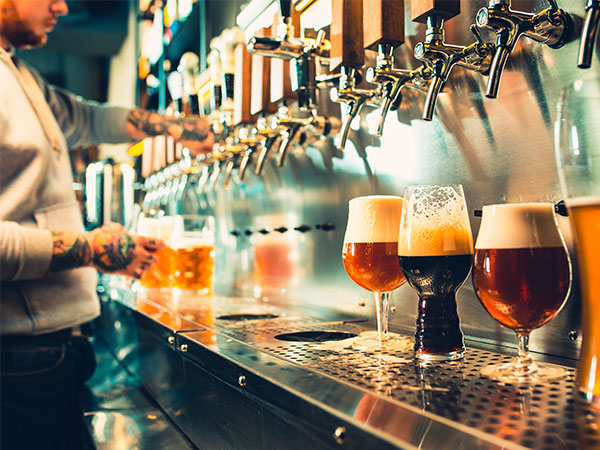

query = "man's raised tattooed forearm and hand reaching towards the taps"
[127, 109, 214, 155]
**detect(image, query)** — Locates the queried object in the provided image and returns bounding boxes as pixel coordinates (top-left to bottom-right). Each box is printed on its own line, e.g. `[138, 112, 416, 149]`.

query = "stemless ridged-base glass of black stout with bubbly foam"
[398, 185, 473, 361]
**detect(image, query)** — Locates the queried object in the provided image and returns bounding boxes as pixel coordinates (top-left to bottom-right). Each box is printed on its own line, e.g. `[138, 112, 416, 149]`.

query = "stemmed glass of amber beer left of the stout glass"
[342, 195, 405, 344]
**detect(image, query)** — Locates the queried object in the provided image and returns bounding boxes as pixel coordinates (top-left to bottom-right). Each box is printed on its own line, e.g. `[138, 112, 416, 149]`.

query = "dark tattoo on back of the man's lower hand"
[92, 232, 135, 272]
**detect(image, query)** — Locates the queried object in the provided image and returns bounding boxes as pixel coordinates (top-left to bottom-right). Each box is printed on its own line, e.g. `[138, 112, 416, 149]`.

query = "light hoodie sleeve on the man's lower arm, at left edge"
[0, 221, 53, 281]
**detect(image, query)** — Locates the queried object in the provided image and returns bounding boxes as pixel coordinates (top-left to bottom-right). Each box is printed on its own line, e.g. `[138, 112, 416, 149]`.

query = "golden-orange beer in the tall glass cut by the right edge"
[567, 197, 600, 406]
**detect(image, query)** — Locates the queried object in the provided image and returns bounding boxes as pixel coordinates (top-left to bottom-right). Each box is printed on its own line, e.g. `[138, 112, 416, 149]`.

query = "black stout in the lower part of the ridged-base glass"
[399, 254, 472, 355]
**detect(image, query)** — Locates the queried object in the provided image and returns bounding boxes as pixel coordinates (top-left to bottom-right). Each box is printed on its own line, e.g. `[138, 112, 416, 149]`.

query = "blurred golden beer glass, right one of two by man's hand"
[170, 214, 215, 294]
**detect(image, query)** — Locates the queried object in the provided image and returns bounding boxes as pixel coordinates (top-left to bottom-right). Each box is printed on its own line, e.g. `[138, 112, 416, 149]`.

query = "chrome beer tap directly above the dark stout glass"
[412, 1, 494, 121]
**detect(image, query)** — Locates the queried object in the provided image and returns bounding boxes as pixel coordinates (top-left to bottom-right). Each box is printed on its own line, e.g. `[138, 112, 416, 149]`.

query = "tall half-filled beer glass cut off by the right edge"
[554, 72, 600, 407]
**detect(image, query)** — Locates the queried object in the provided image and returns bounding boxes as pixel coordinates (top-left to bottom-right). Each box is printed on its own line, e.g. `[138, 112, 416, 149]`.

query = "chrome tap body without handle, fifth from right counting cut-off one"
[330, 67, 377, 150]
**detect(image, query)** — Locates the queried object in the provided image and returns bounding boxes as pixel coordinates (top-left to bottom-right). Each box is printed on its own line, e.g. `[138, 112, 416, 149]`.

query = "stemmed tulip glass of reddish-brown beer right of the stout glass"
[473, 203, 571, 384]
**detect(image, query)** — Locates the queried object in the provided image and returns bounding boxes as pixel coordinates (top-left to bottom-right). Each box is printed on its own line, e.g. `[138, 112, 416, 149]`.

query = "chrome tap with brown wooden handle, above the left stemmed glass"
[363, 0, 428, 137]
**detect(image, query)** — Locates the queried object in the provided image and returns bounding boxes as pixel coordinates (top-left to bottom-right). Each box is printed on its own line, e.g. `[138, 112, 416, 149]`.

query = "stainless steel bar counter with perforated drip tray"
[96, 277, 600, 449]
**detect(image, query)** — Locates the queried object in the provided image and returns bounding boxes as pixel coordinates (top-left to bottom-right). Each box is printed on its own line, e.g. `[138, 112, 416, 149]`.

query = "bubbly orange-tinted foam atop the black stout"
[398, 186, 473, 256]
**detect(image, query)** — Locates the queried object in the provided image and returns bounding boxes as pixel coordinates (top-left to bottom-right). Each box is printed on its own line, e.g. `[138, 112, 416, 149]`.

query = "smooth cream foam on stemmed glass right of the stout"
[475, 203, 563, 249]
